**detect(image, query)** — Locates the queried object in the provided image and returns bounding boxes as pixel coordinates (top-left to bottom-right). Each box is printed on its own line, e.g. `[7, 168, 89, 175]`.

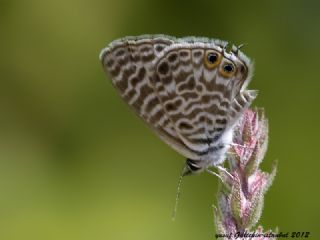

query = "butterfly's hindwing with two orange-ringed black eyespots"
[153, 39, 256, 161]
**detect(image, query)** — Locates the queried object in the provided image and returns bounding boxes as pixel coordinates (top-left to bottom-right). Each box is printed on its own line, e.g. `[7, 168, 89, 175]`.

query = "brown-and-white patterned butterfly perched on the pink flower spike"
[100, 35, 257, 175]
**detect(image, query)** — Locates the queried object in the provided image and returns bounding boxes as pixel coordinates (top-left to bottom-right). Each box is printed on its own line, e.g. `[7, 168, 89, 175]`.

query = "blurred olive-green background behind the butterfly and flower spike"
[0, 0, 320, 240]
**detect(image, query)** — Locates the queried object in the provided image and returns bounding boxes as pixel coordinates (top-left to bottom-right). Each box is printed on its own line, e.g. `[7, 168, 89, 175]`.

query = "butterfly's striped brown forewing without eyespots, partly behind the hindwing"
[100, 35, 200, 158]
